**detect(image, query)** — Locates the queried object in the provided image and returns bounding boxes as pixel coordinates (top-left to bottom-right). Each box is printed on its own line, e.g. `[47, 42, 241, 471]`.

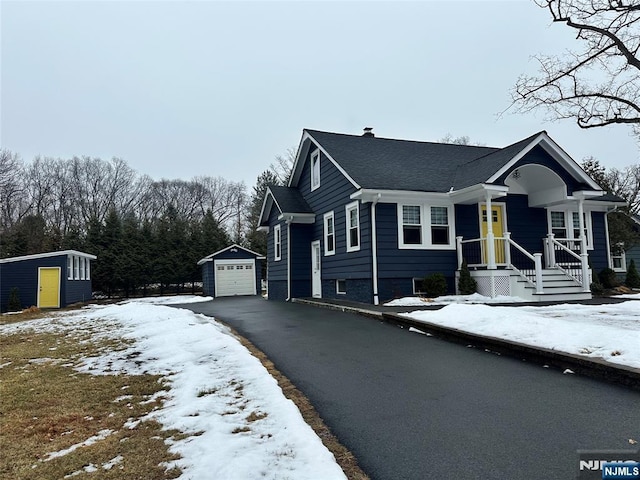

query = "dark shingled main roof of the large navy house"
[306, 130, 538, 192]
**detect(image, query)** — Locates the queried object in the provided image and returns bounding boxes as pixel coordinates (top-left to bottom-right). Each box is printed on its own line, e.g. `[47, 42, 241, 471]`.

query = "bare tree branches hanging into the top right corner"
[511, 0, 640, 134]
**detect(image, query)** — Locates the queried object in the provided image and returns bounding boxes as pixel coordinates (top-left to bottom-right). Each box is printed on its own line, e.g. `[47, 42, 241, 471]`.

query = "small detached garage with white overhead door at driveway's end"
[198, 245, 264, 297]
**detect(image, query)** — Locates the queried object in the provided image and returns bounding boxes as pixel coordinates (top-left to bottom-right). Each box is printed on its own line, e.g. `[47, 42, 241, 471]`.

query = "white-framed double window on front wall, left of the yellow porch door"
[398, 204, 455, 249]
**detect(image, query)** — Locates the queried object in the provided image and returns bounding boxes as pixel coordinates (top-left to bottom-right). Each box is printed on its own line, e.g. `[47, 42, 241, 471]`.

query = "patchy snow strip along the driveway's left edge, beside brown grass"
[0, 297, 346, 480]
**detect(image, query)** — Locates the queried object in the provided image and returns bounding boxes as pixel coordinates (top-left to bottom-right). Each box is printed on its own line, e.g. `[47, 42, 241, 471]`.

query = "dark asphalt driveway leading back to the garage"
[178, 297, 640, 480]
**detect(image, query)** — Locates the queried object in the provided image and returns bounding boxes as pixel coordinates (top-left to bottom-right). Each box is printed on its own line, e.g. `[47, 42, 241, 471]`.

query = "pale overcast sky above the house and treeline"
[0, 0, 638, 187]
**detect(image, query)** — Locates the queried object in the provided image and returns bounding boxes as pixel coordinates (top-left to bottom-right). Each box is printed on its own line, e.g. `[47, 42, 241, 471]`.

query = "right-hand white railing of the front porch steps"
[544, 233, 590, 292]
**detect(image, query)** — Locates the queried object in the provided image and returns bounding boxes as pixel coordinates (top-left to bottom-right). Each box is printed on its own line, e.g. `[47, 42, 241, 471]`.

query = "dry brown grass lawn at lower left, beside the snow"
[0, 312, 185, 480]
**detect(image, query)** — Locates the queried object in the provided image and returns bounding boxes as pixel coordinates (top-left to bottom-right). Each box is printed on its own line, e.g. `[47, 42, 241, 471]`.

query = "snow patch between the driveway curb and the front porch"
[402, 296, 640, 368]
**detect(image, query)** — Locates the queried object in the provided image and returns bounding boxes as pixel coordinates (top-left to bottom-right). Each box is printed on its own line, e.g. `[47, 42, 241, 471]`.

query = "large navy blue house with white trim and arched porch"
[259, 129, 621, 304]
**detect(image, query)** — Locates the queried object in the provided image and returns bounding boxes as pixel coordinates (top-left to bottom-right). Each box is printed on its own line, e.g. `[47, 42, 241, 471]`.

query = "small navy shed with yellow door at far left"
[0, 250, 96, 312]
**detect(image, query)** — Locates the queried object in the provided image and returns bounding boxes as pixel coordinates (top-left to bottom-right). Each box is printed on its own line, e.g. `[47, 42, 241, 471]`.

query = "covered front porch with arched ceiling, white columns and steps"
[453, 164, 601, 301]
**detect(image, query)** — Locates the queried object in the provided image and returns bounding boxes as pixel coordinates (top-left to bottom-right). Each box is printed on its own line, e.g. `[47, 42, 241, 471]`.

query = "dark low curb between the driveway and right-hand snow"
[293, 299, 640, 390]
